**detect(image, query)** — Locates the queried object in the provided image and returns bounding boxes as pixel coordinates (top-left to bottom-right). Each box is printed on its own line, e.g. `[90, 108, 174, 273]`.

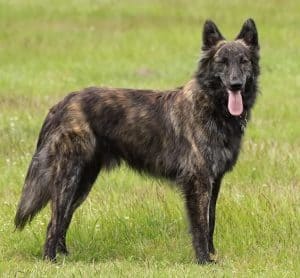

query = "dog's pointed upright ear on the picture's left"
[202, 20, 225, 50]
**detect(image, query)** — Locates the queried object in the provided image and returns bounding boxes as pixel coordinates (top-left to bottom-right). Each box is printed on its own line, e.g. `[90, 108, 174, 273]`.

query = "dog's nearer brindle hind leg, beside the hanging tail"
[44, 154, 83, 261]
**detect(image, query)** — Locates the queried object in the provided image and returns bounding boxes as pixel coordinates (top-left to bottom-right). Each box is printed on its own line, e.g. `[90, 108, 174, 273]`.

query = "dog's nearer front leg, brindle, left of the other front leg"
[184, 176, 212, 264]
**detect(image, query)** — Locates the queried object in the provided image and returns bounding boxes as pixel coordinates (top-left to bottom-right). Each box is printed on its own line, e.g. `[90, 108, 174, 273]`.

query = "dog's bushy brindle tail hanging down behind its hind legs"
[15, 153, 51, 230]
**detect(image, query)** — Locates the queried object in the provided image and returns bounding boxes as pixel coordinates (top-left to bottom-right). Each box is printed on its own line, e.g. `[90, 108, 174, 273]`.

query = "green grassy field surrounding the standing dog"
[0, 0, 300, 277]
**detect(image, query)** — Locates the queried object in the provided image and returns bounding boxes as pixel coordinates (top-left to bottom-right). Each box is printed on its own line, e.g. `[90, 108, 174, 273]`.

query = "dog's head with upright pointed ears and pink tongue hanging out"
[197, 19, 259, 116]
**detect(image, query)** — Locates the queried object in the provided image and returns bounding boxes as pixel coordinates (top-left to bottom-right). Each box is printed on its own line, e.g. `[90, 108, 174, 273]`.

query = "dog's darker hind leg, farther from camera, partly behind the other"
[57, 158, 101, 255]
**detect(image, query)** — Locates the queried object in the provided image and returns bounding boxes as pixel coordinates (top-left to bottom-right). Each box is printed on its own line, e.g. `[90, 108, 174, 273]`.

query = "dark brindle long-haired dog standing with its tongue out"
[15, 19, 260, 264]
